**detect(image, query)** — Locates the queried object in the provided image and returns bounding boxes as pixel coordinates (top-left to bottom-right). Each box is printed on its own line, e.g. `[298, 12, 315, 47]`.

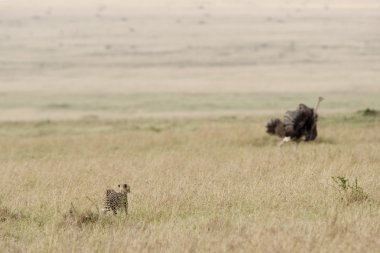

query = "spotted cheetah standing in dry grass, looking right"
[102, 184, 131, 215]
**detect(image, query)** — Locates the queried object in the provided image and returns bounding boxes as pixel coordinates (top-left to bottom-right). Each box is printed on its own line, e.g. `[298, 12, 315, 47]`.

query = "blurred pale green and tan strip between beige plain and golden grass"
[0, 91, 380, 121]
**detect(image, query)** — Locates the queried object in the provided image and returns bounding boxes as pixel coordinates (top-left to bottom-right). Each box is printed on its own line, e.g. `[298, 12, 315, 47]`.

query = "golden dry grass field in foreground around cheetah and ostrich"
[0, 115, 380, 252]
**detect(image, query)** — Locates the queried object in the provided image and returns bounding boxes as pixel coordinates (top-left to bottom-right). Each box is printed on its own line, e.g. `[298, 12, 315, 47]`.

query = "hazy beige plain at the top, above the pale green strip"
[0, 0, 380, 94]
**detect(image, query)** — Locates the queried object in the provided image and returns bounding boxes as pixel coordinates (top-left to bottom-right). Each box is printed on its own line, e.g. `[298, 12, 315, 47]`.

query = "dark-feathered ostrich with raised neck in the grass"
[266, 97, 324, 147]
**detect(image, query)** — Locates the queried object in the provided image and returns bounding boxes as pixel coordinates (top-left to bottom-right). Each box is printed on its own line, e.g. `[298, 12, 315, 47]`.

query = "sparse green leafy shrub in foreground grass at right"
[332, 177, 368, 204]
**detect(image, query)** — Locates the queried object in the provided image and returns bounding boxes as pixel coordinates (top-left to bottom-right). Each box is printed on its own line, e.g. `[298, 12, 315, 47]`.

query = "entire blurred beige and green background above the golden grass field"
[0, 0, 380, 121]
